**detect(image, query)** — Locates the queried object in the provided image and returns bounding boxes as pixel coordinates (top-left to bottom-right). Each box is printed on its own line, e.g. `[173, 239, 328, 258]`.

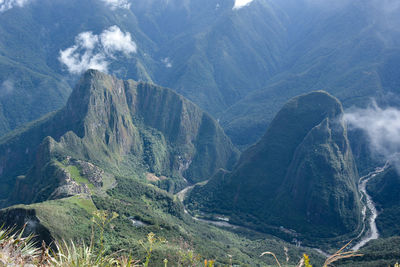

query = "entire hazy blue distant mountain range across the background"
[0, 0, 400, 151]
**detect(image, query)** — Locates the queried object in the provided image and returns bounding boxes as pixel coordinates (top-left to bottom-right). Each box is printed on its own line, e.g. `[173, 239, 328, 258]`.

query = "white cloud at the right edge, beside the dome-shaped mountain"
[344, 103, 400, 173]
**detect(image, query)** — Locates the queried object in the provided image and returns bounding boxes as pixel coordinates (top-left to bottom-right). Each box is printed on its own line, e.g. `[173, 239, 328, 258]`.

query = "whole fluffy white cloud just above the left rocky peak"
[59, 26, 137, 74]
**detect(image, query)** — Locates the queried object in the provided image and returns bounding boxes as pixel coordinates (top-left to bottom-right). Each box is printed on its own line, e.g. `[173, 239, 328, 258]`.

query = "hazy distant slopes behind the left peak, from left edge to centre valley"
[0, 0, 285, 139]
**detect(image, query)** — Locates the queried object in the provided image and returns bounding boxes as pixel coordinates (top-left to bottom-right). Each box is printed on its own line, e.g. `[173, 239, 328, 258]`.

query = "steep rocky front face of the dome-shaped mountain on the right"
[274, 117, 360, 237]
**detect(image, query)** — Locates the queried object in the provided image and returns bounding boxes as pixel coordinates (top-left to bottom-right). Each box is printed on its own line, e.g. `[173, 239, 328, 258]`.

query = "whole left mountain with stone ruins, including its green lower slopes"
[0, 70, 321, 266]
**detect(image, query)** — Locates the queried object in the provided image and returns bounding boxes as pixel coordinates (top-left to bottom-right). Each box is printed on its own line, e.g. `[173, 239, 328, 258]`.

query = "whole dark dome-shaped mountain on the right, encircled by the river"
[187, 91, 361, 245]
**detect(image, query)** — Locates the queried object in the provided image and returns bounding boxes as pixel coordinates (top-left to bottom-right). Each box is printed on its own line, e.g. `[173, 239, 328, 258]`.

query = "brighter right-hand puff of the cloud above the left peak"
[100, 26, 137, 55]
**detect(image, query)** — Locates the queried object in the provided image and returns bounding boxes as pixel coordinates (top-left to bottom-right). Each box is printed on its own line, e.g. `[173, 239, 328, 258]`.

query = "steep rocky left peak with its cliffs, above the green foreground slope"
[0, 70, 238, 206]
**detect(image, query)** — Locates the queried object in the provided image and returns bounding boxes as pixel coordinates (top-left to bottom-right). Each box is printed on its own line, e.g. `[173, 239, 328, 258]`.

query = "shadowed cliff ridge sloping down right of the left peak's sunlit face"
[129, 83, 237, 182]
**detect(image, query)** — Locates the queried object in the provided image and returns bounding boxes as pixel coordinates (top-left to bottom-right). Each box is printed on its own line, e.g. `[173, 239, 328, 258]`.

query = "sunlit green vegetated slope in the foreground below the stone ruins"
[0, 178, 322, 266]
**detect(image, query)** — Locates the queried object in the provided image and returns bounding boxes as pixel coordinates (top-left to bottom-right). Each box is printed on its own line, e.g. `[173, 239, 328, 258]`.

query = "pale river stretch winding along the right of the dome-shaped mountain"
[352, 163, 389, 251]
